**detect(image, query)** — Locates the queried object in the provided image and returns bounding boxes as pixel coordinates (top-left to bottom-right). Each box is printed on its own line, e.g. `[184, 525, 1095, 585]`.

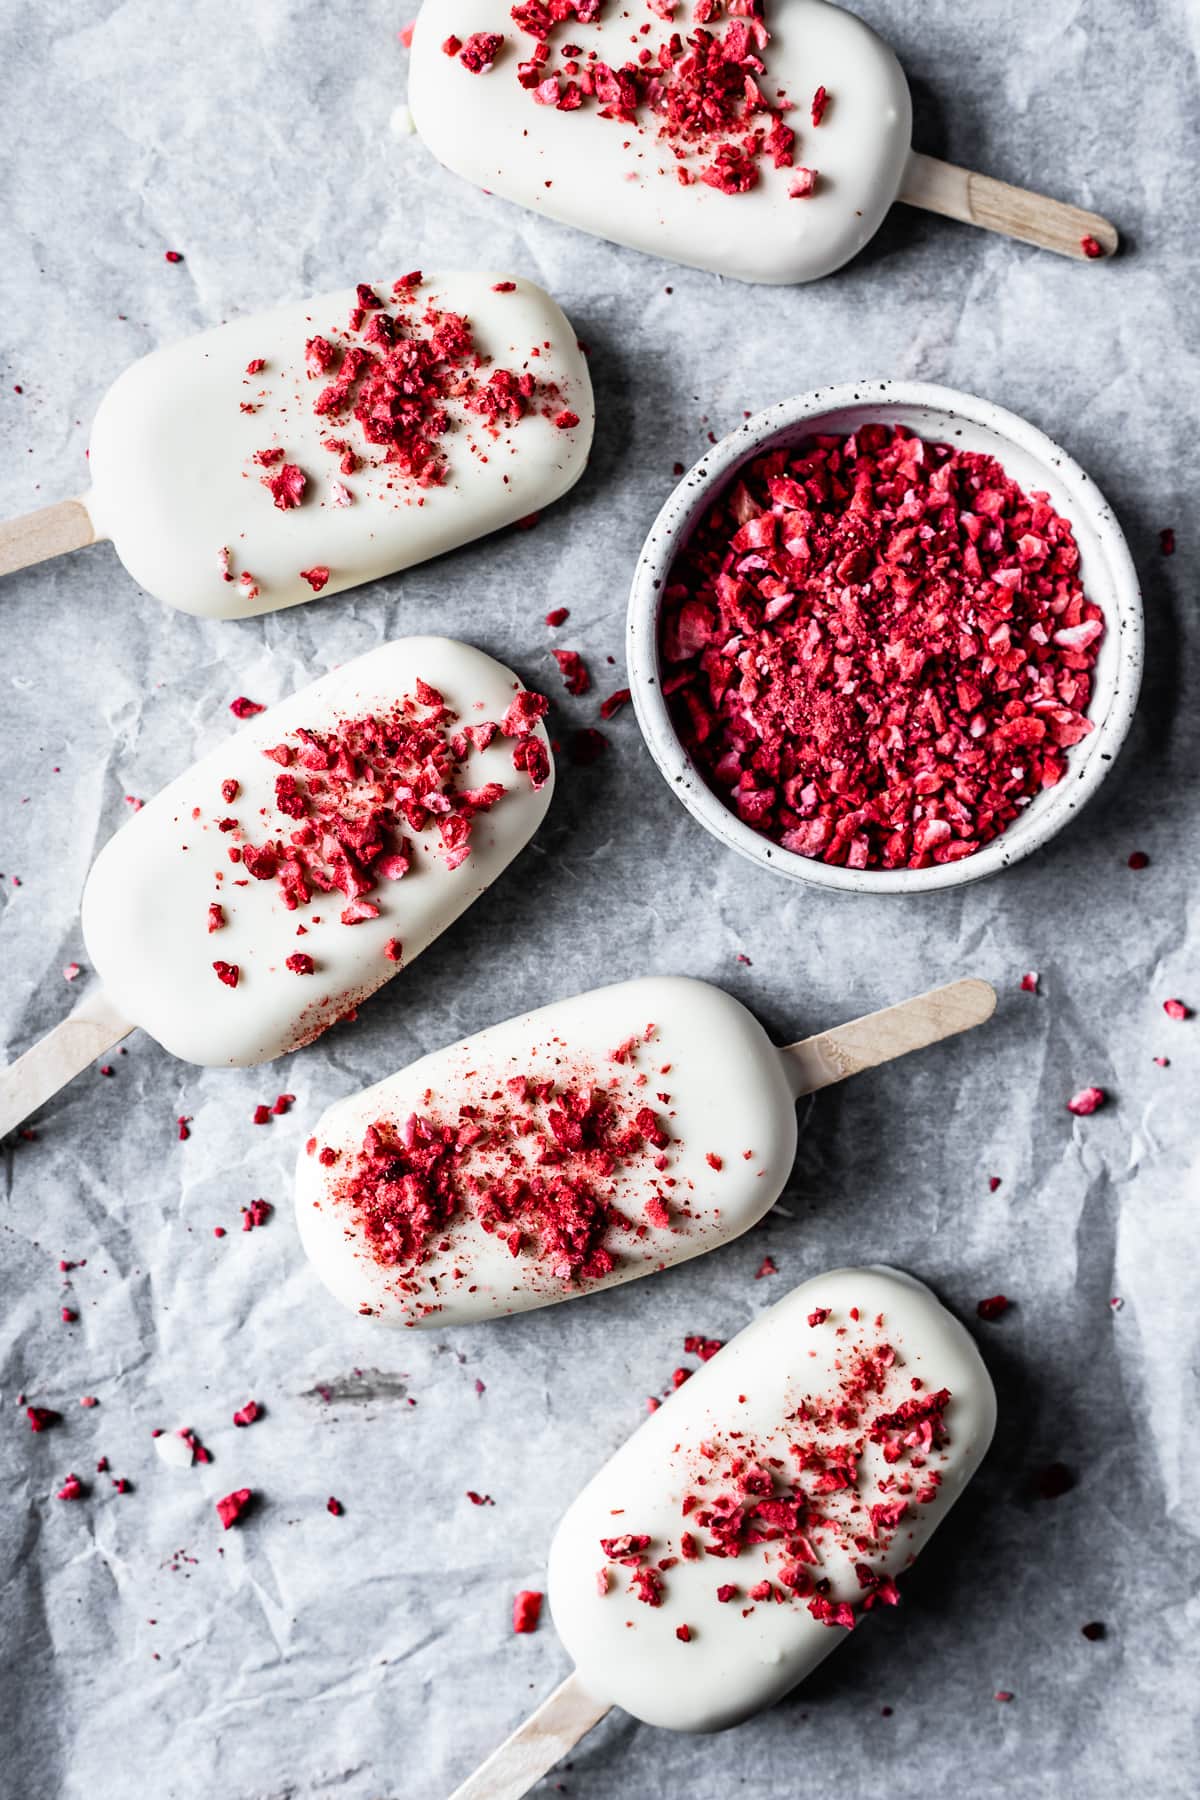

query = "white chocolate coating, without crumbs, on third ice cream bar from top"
[83, 637, 554, 1066]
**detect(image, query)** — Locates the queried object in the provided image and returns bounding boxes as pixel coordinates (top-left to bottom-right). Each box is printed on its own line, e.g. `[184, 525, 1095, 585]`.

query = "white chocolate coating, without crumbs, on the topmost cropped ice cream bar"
[408, 0, 912, 283]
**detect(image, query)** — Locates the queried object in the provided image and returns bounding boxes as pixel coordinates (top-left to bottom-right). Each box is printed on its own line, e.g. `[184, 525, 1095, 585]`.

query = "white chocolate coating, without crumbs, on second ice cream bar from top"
[86, 272, 594, 619]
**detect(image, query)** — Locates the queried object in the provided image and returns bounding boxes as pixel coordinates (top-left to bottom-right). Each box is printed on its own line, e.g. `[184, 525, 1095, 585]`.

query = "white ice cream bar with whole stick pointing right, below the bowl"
[297, 977, 995, 1327]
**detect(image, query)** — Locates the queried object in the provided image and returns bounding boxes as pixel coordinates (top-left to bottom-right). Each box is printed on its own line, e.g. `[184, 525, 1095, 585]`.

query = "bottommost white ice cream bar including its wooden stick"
[453, 1269, 995, 1800]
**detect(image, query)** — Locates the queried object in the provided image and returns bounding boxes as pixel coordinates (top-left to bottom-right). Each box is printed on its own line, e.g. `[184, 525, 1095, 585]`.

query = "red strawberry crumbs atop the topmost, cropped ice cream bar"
[503, 0, 824, 194]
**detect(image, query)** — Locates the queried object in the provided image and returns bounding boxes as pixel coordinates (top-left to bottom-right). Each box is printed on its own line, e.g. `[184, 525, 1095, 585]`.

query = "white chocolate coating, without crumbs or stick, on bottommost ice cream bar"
[549, 1269, 995, 1732]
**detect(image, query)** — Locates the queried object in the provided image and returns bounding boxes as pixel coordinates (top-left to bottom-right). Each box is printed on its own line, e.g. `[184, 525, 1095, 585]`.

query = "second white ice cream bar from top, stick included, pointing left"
[0, 272, 594, 619]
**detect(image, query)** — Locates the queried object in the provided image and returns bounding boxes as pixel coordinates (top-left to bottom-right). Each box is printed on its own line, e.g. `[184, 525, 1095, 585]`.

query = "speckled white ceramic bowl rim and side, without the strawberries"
[626, 382, 1144, 893]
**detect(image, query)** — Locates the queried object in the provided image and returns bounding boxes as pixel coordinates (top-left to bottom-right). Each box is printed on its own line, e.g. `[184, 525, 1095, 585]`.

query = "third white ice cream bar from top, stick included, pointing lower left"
[0, 637, 552, 1130]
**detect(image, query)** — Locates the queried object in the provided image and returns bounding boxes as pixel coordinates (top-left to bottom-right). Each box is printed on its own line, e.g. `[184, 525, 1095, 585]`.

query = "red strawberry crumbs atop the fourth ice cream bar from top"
[318, 1053, 675, 1310]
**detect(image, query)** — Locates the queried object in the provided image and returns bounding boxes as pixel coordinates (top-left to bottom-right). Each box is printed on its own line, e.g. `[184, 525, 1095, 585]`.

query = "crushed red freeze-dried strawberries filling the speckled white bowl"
[658, 425, 1105, 869]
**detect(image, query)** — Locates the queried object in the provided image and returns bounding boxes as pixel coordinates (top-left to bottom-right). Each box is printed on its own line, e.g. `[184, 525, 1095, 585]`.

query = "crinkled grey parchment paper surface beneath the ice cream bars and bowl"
[0, 0, 1200, 1800]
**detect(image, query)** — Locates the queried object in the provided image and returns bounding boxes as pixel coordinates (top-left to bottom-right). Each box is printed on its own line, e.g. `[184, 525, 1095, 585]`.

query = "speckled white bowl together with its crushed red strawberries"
[626, 382, 1142, 893]
